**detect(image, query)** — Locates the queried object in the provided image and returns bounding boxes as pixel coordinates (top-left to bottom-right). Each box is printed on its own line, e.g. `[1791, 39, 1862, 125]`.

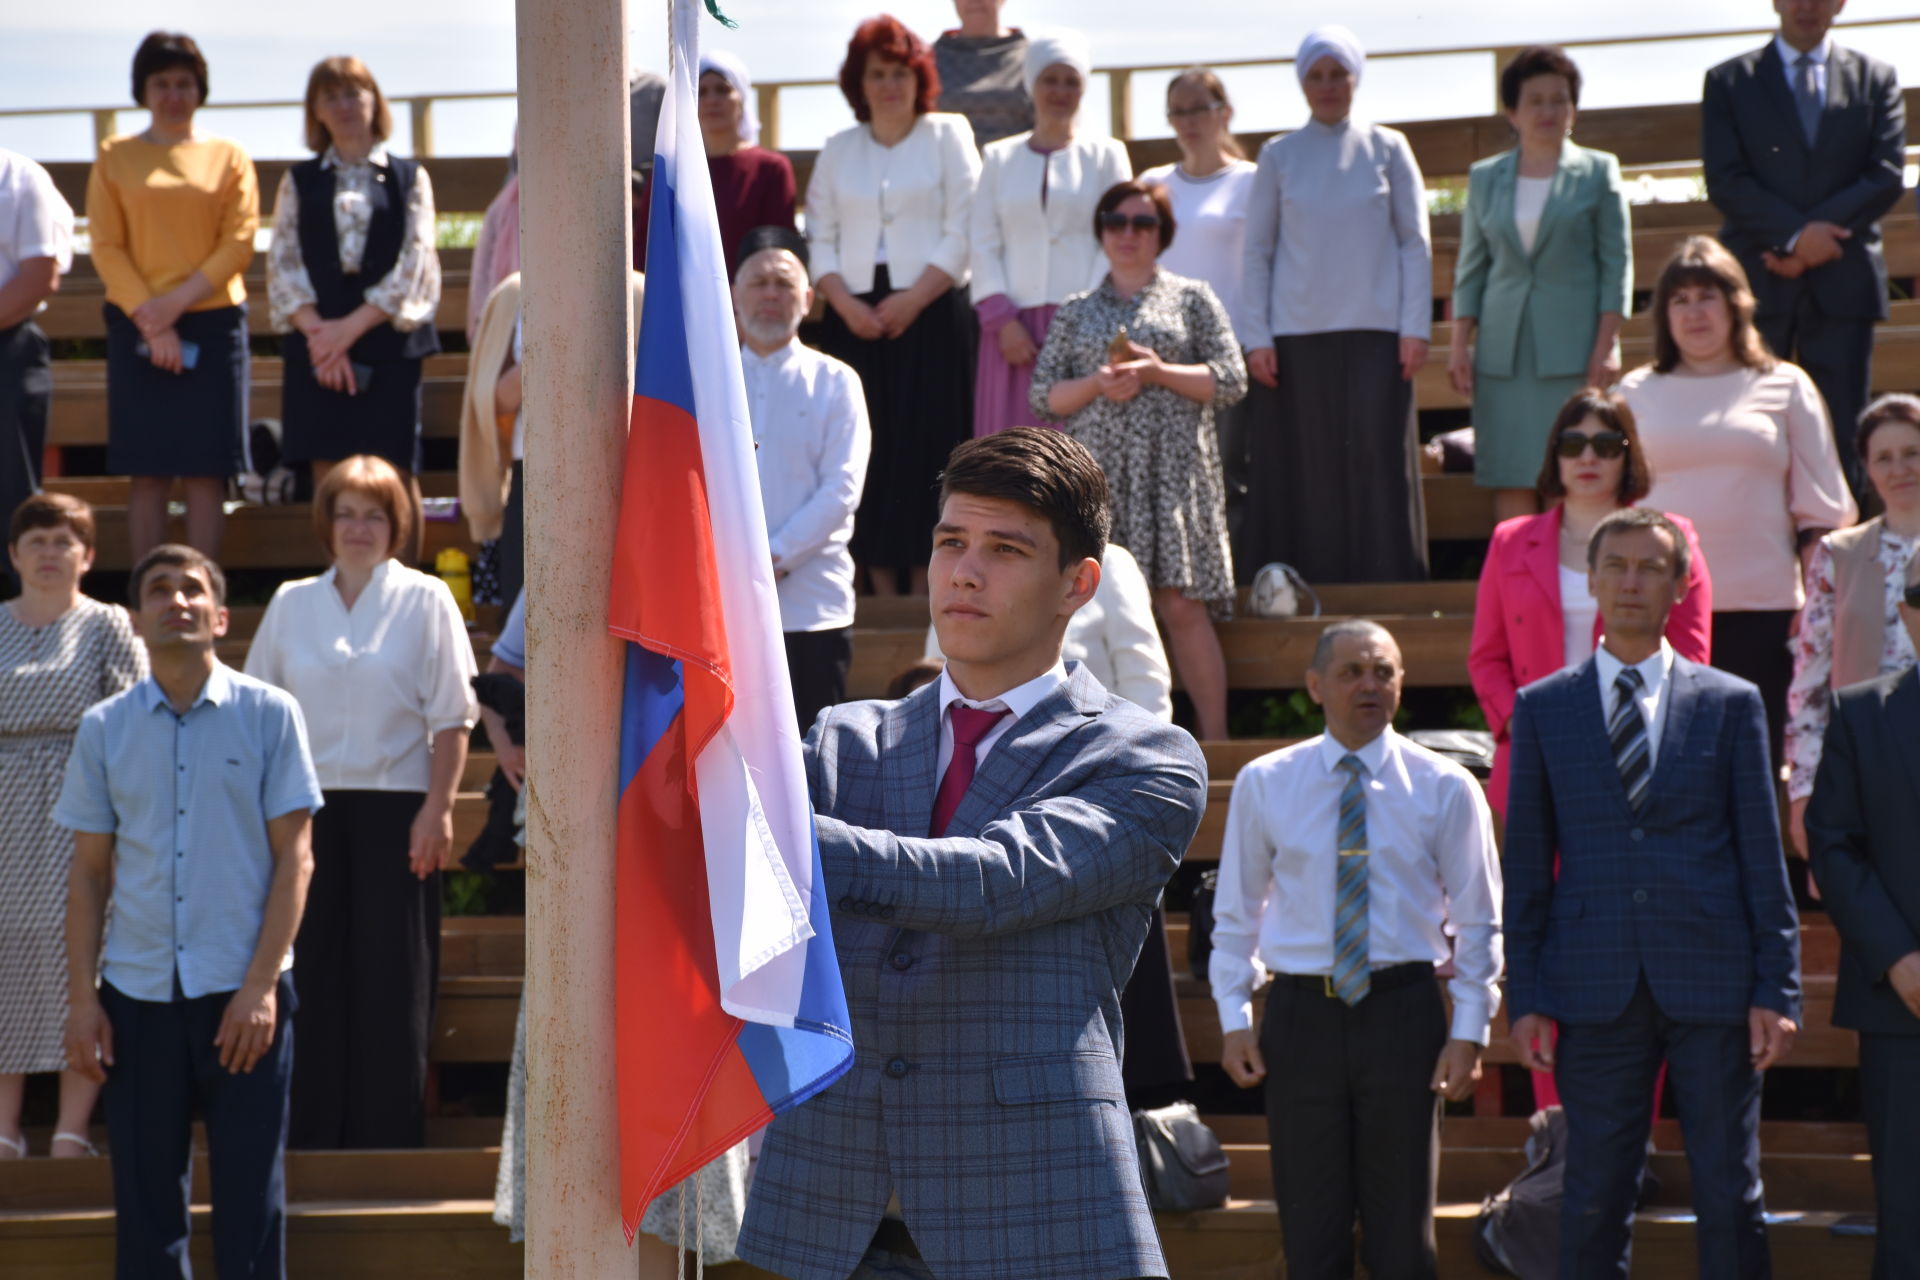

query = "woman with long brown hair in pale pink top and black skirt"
[1620, 236, 1857, 768]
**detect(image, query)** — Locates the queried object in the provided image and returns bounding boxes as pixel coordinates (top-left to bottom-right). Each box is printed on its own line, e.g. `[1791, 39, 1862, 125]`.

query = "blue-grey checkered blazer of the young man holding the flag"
[739, 664, 1206, 1280]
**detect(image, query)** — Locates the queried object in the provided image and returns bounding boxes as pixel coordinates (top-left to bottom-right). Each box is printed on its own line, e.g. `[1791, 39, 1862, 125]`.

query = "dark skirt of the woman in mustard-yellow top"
[104, 303, 248, 476]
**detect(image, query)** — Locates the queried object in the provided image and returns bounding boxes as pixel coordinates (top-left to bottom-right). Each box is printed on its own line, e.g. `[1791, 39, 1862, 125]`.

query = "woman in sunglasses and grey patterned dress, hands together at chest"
[1031, 178, 1246, 739]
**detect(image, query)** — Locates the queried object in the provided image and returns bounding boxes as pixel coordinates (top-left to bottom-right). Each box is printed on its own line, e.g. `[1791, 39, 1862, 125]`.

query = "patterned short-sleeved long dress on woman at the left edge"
[0, 597, 146, 1075]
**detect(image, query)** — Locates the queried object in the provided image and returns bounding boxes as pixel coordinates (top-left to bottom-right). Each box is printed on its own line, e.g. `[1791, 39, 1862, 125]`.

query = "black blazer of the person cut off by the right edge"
[1807, 670, 1920, 1036]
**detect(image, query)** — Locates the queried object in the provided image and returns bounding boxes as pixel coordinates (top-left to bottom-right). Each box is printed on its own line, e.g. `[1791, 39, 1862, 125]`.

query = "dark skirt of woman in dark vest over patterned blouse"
[280, 330, 420, 476]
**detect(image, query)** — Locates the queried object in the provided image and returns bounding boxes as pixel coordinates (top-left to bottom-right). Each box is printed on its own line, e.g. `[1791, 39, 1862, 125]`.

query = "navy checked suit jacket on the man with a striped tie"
[1503, 656, 1801, 1025]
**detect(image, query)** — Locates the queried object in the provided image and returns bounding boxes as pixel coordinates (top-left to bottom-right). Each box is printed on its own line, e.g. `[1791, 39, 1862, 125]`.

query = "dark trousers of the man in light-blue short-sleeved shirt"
[100, 973, 296, 1280]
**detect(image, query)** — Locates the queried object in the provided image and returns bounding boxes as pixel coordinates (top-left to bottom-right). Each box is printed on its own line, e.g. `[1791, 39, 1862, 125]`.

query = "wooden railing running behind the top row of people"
[0, 13, 1920, 155]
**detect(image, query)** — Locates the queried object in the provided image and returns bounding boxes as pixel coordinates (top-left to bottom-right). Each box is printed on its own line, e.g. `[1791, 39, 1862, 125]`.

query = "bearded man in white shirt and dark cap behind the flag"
[733, 226, 872, 735]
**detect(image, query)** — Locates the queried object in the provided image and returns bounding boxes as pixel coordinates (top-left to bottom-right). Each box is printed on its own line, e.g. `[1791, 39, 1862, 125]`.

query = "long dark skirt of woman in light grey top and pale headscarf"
[1236, 330, 1427, 583]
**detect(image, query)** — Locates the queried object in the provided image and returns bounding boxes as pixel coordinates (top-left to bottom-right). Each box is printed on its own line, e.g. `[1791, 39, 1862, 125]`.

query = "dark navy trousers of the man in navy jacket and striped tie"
[1553, 979, 1772, 1280]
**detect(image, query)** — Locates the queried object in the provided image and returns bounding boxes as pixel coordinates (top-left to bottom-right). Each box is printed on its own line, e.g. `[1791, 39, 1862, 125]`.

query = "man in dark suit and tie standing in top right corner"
[1699, 0, 1907, 493]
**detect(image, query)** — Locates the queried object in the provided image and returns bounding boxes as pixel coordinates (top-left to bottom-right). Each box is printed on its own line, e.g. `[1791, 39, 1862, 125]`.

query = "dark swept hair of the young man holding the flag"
[941, 426, 1112, 568]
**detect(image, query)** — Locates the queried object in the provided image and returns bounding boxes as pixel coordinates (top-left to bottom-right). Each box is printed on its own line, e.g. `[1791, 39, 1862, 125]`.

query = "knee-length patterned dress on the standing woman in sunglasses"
[1033, 269, 1246, 618]
